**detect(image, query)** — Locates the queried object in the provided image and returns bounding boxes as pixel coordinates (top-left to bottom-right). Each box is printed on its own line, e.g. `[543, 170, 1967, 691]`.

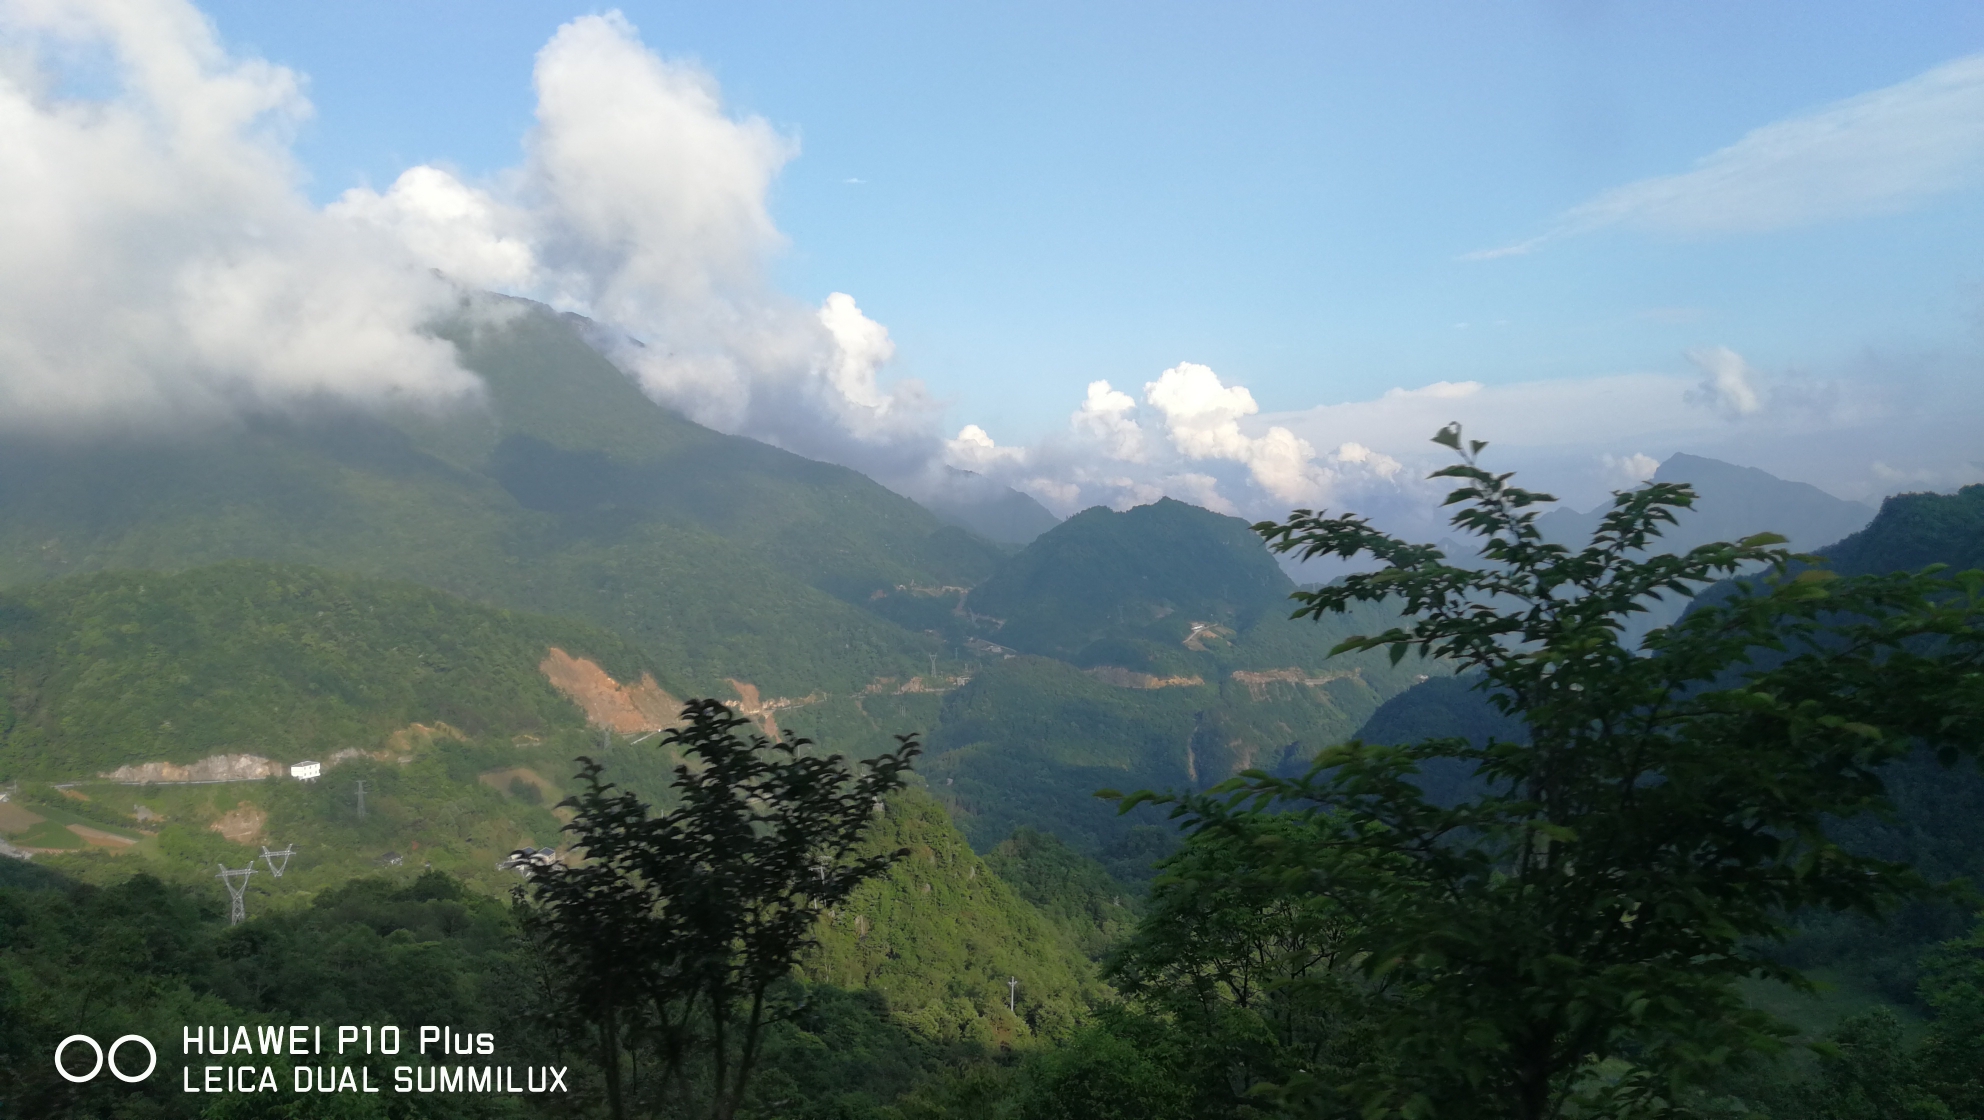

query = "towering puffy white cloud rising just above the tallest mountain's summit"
[333, 12, 942, 492]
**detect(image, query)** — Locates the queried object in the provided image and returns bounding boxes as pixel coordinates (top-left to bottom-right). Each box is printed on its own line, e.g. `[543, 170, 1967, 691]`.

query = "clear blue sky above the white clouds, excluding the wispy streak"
[206, 2, 1984, 424]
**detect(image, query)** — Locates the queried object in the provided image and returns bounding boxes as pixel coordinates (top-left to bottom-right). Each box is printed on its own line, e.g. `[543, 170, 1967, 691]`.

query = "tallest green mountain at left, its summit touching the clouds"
[0, 297, 1002, 728]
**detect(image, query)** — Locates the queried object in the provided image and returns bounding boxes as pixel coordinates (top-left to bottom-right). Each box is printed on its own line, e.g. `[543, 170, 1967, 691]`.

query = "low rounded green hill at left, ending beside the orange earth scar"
[0, 561, 673, 779]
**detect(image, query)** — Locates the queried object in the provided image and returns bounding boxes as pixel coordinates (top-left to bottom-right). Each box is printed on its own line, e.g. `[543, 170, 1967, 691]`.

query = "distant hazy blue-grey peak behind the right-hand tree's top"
[1536, 454, 1875, 551]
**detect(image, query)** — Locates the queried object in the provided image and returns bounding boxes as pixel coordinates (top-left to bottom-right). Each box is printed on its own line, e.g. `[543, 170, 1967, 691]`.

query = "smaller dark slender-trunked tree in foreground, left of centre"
[520, 700, 921, 1120]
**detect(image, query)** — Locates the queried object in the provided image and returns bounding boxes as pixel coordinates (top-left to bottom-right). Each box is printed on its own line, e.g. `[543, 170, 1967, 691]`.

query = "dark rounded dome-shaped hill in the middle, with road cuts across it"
[925, 500, 1442, 862]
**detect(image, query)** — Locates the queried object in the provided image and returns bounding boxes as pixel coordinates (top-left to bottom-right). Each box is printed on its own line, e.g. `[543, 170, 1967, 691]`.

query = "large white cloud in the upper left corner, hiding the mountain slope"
[0, 0, 478, 426]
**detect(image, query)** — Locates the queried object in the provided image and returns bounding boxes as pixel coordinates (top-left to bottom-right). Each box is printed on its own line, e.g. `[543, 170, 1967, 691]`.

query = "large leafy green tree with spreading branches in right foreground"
[1105, 424, 1984, 1120]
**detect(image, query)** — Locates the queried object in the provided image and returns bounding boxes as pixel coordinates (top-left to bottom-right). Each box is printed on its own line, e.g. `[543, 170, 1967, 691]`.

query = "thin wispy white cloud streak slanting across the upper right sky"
[1468, 54, 1984, 260]
